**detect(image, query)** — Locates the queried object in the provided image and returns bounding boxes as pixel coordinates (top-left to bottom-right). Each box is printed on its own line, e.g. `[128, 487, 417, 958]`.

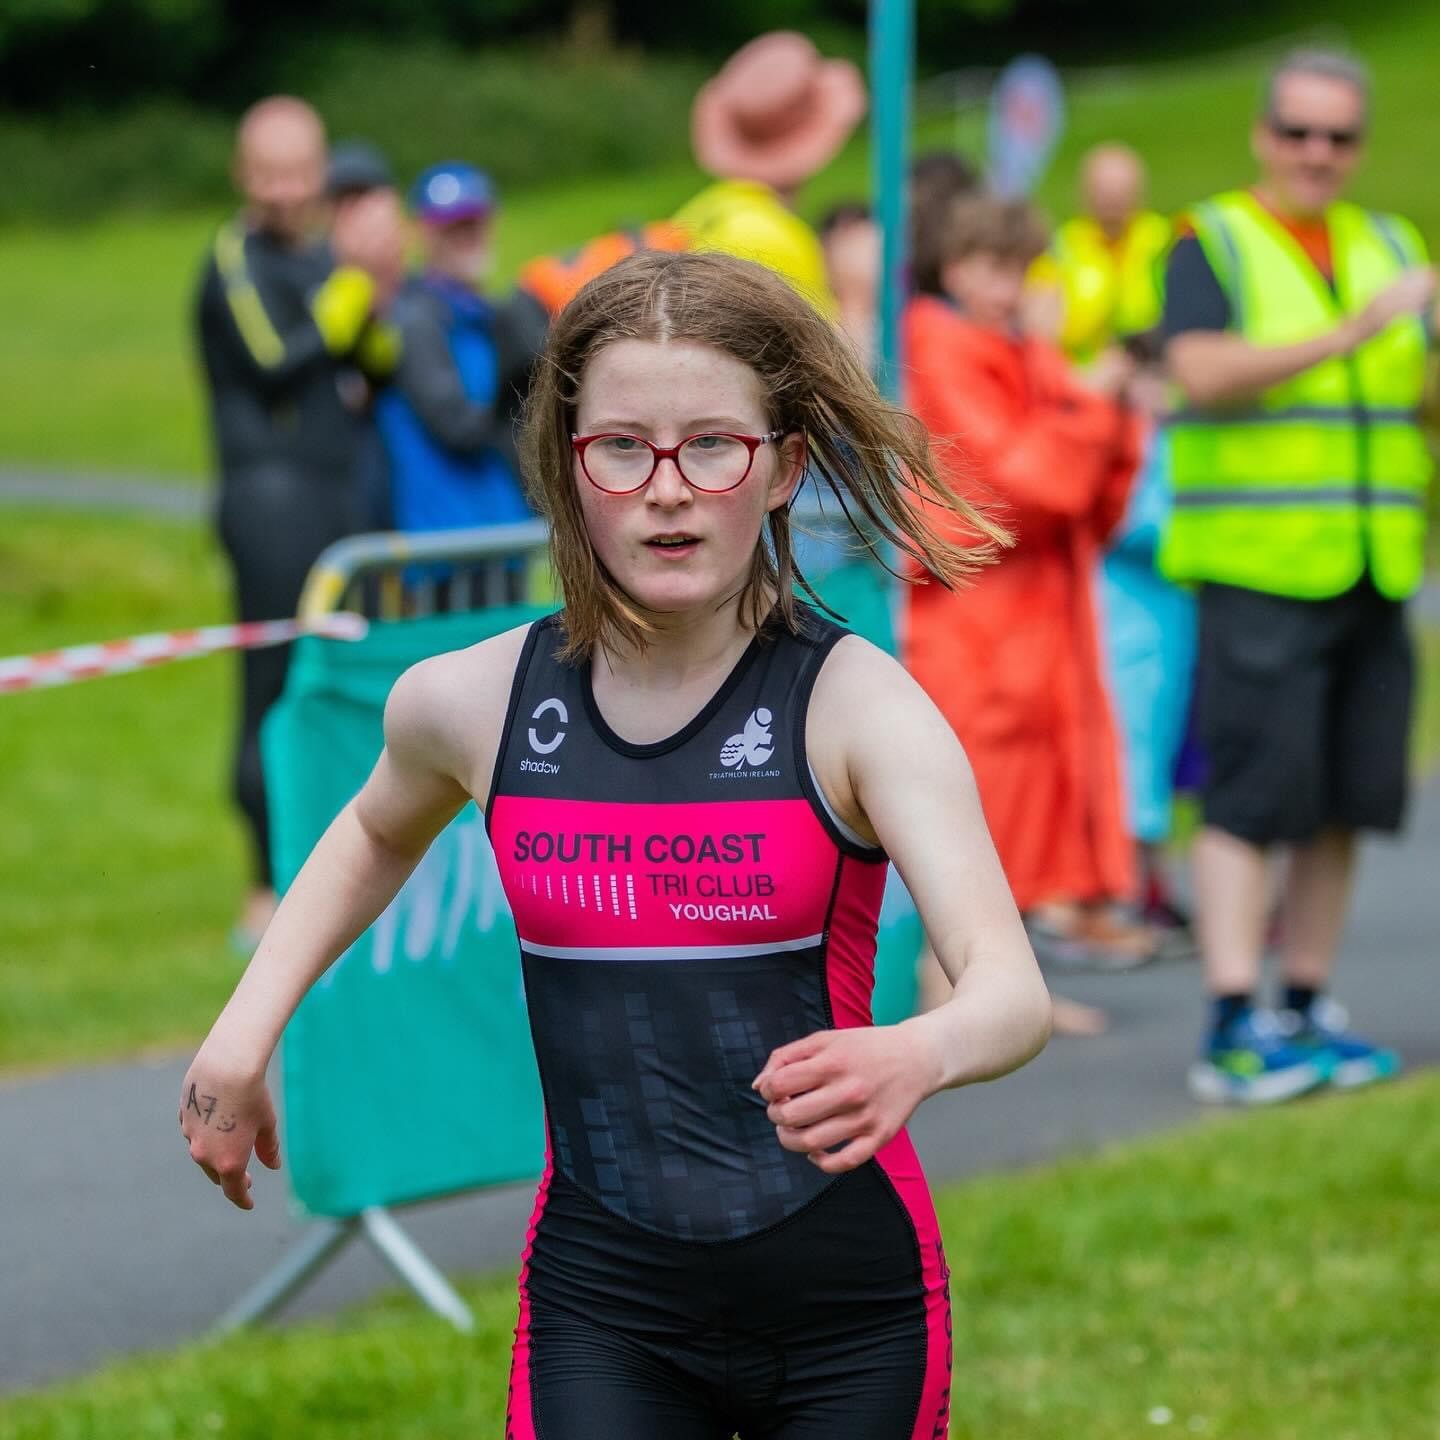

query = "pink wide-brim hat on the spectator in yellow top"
[690, 30, 867, 190]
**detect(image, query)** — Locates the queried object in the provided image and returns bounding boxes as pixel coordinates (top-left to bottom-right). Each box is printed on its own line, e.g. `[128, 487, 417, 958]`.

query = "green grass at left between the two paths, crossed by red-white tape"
[0, 510, 245, 1066]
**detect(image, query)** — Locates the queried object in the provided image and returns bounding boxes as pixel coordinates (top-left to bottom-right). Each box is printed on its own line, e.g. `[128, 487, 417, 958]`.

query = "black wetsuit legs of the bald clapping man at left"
[219, 465, 366, 886]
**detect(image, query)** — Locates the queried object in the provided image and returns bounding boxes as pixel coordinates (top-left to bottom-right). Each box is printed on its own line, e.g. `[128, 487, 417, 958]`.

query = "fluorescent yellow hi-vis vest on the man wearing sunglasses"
[1161, 192, 1431, 599]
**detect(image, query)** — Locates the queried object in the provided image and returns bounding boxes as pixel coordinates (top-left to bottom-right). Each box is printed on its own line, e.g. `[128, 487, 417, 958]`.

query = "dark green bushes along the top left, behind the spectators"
[0, 40, 707, 223]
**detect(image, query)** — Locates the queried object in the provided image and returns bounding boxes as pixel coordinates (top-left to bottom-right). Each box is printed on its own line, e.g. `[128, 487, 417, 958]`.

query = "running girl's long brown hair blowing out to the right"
[520, 251, 1009, 658]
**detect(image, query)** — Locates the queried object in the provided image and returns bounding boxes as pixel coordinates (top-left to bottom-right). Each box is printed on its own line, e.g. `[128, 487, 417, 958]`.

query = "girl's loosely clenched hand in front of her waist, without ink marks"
[755, 1025, 943, 1175]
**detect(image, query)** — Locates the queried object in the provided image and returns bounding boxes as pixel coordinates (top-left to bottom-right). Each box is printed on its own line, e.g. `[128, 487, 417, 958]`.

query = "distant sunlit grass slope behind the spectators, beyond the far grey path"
[0, 7, 1440, 475]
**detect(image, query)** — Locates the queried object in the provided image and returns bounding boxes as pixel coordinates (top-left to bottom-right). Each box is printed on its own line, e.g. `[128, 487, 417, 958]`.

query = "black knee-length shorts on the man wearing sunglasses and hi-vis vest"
[1197, 579, 1414, 845]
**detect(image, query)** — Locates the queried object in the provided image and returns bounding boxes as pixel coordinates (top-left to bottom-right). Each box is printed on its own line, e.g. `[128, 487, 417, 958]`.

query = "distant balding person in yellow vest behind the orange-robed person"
[1031, 143, 1172, 367]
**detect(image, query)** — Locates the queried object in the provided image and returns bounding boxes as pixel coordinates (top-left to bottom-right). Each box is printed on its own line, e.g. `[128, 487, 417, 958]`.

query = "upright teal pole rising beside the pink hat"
[870, 0, 914, 400]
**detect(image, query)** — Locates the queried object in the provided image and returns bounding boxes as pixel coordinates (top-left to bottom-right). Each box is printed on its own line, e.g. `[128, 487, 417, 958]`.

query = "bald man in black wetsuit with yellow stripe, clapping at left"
[196, 96, 403, 946]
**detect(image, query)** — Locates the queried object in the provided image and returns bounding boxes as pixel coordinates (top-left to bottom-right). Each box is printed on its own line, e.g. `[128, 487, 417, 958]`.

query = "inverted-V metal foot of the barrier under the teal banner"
[212, 1205, 475, 1335]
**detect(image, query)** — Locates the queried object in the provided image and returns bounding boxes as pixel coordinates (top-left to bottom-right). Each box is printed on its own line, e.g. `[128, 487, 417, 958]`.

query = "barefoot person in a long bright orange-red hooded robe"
[904, 197, 1153, 1031]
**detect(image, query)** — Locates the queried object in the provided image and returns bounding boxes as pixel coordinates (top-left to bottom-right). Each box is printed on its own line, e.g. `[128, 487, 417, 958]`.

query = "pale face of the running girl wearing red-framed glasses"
[573, 340, 805, 616]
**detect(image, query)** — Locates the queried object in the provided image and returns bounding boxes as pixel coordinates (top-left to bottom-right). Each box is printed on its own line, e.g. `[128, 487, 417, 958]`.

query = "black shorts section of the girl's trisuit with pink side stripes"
[505, 1161, 950, 1440]
